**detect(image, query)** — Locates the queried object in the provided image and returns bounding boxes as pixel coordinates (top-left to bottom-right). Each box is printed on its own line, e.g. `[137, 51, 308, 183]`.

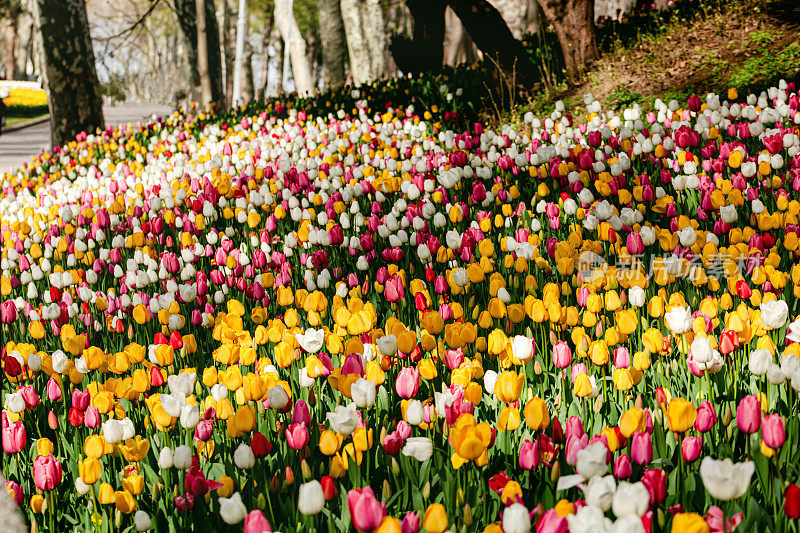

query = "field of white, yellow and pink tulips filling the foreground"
[0, 75, 800, 533]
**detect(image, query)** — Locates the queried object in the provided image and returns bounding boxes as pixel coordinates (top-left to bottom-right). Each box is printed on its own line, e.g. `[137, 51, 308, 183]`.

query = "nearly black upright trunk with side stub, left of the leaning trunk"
[390, 0, 447, 72]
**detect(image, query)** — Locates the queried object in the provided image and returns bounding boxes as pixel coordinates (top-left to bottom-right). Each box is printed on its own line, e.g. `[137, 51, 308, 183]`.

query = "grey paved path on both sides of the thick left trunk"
[0, 104, 171, 175]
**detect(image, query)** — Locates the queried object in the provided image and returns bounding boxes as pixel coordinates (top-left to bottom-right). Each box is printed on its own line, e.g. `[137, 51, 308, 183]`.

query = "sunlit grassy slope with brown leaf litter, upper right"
[501, 0, 800, 122]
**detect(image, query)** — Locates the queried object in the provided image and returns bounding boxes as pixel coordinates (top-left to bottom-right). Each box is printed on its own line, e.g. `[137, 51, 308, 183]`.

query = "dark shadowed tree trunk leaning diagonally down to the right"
[447, 0, 536, 89]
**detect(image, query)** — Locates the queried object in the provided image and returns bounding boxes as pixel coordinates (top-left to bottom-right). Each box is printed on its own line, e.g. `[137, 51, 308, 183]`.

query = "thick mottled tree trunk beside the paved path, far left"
[36, 0, 104, 146]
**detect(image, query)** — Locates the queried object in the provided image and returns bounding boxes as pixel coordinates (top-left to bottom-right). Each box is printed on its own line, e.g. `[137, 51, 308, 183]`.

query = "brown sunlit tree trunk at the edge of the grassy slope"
[539, 0, 600, 84]
